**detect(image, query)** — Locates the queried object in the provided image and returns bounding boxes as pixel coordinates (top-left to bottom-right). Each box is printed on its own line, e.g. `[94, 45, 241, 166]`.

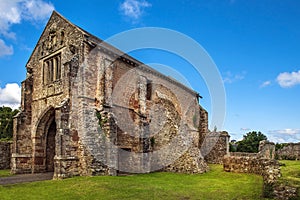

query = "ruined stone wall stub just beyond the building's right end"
[201, 131, 230, 164]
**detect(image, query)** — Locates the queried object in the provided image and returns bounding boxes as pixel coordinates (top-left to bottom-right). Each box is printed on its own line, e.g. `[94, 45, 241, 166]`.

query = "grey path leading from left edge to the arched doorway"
[0, 172, 53, 185]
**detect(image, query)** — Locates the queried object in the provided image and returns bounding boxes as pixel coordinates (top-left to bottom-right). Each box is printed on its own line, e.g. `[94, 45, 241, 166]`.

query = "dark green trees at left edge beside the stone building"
[0, 106, 19, 140]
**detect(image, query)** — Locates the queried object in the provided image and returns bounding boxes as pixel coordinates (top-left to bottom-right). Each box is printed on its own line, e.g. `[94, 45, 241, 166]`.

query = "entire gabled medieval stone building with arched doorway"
[11, 11, 208, 178]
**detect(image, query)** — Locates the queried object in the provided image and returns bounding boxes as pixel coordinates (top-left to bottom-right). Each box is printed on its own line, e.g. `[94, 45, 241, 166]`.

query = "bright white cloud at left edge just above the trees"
[0, 83, 21, 108]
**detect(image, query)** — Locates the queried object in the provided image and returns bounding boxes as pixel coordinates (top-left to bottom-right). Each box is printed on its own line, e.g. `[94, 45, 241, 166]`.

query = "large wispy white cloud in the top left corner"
[0, 0, 54, 53]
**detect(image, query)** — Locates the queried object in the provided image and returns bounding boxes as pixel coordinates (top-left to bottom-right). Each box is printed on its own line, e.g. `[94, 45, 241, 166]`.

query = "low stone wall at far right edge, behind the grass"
[276, 142, 300, 160]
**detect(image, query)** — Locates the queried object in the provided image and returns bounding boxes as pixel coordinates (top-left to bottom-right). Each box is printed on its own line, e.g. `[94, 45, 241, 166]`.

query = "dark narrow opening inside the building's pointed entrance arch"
[46, 120, 56, 172]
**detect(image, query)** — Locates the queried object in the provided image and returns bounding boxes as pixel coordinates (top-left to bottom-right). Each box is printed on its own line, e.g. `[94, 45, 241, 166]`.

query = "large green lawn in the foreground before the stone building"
[0, 165, 262, 200]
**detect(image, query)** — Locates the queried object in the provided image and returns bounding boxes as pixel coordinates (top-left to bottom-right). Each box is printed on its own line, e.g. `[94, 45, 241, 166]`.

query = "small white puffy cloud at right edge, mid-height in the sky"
[277, 70, 300, 88]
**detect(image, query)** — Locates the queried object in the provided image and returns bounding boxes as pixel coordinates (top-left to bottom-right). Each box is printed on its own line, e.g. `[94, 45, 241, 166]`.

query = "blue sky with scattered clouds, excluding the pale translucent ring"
[0, 0, 300, 142]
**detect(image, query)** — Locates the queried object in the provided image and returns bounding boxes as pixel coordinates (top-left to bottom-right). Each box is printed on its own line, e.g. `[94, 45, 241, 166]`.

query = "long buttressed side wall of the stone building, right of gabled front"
[76, 32, 208, 175]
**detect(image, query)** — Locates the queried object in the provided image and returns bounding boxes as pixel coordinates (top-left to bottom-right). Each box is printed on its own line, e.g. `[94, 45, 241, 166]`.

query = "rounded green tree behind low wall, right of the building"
[237, 131, 267, 153]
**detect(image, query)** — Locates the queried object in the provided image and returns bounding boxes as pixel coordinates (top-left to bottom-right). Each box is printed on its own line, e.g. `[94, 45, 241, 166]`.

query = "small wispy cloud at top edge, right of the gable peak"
[120, 0, 152, 20]
